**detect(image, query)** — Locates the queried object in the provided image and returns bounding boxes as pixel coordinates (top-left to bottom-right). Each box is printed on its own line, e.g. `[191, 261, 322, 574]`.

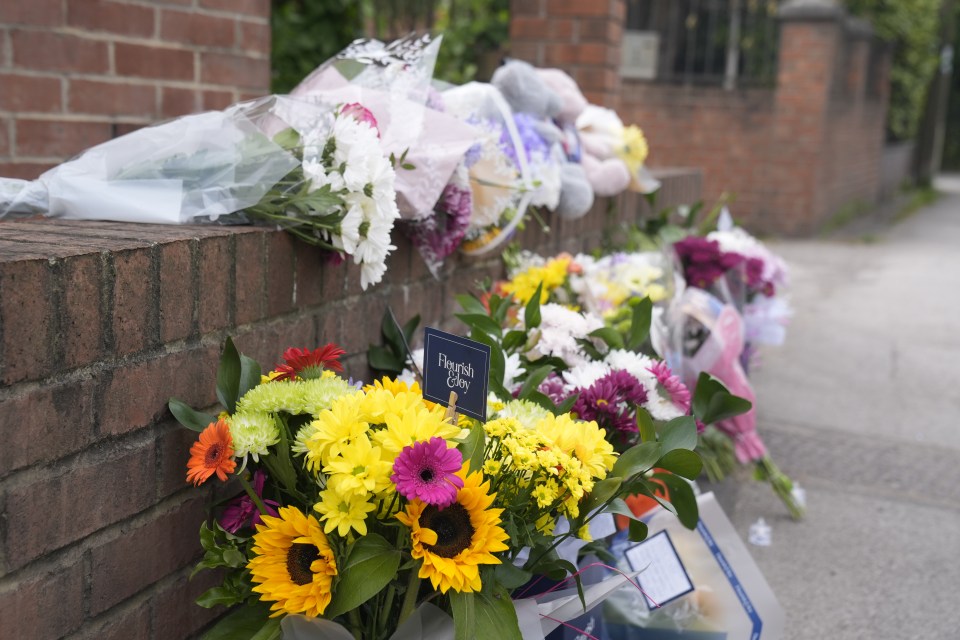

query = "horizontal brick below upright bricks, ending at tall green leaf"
[98, 347, 219, 435]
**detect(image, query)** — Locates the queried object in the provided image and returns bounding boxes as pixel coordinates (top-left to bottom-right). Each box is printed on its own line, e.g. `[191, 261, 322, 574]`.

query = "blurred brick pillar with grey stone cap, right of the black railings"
[767, 0, 844, 233]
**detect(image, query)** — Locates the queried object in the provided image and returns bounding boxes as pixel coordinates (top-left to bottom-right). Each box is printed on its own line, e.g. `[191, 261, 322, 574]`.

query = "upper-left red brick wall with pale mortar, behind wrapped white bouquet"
[0, 0, 270, 178]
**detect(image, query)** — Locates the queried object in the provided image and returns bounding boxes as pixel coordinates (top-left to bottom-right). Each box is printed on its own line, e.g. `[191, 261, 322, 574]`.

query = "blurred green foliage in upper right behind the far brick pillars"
[846, 0, 941, 140]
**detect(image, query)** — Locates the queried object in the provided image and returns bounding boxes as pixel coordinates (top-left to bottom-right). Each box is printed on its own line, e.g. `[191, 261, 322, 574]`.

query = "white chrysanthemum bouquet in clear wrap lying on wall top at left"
[0, 96, 399, 288]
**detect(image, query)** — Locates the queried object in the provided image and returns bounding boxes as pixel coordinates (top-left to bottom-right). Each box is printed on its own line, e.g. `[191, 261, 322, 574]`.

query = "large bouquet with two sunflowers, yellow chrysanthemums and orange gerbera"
[170, 340, 700, 639]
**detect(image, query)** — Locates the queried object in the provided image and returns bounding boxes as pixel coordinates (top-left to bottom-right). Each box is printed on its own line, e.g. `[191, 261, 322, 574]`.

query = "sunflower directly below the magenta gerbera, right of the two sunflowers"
[397, 465, 509, 593]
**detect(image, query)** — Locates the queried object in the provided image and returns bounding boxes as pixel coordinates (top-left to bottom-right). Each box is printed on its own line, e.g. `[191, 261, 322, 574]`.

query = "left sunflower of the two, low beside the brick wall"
[247, 507, 337, 617]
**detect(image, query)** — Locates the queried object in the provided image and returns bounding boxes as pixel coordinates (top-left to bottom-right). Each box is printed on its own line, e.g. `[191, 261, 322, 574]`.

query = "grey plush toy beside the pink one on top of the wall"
[491, 60, 594, 219]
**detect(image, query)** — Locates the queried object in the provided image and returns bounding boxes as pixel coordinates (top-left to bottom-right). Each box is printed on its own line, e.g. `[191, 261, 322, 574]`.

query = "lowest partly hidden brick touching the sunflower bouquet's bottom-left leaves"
[152, 564, 223, 640]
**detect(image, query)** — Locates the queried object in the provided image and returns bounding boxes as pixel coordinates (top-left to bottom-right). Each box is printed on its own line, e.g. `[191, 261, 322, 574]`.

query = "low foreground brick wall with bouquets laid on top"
[0, 173, 700, 640]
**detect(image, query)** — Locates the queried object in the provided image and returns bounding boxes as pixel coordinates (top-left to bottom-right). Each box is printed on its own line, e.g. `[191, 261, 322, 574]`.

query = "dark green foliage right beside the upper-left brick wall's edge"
[270, 0, 363, 93]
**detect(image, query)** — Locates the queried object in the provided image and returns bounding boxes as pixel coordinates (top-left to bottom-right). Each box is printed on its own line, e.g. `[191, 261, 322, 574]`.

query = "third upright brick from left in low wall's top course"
[112, 249, 157, 355]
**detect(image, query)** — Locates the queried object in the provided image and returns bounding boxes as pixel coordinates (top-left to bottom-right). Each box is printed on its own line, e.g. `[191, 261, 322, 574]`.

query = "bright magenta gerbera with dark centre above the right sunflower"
[390, 438, 463, 509]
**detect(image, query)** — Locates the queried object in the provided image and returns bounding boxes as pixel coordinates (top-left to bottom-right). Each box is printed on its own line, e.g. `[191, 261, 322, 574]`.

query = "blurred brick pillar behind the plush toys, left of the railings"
[510, 0, 627, 109]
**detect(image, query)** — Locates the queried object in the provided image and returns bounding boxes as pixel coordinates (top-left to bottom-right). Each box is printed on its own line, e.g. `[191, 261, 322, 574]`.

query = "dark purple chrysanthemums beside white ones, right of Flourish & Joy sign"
[573, 370, 647, 443]
